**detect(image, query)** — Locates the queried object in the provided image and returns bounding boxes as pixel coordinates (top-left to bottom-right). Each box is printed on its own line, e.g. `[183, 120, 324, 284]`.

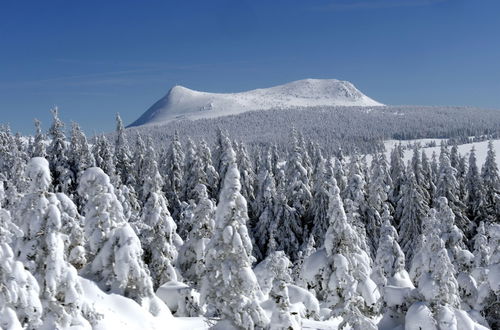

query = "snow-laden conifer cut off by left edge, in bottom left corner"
[0, 208, 42, 329]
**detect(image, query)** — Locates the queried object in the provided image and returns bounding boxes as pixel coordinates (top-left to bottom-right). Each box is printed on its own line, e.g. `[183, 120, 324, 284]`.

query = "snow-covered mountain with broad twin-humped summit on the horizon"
[130, 79, 383, 126]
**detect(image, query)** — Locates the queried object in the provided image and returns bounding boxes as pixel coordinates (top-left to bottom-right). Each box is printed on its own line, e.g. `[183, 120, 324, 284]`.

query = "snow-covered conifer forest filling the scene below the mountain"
[0, 109, 500, 330]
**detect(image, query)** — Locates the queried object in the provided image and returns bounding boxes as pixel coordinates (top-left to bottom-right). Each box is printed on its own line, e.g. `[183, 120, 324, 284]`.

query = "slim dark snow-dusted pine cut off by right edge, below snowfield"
[481, 141, 500, 222]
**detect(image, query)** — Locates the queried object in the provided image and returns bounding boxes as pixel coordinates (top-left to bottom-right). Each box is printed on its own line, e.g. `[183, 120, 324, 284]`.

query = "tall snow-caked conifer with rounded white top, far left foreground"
[16, 157, 88, 328]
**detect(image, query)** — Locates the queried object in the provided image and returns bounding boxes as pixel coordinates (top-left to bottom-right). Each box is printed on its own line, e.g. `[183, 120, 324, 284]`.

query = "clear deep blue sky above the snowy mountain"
[0, 0, 500, 134]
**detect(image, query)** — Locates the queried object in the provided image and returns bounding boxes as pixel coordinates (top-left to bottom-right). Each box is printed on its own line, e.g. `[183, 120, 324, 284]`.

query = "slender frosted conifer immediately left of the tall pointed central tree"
[177, 184, 215, 288]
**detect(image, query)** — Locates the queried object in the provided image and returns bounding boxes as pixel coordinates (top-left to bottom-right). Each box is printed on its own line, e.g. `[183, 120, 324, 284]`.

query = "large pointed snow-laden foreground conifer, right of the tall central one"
[322, 183, 379, 329]
